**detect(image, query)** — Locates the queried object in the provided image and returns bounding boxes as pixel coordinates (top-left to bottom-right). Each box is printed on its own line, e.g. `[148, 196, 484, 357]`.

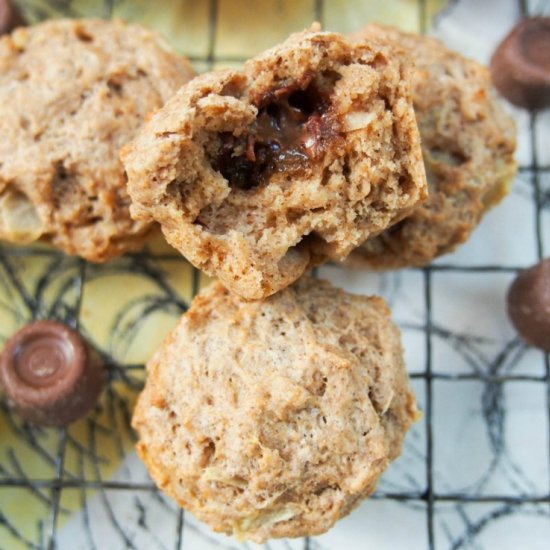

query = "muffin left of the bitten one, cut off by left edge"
[0, 20, 193, 261]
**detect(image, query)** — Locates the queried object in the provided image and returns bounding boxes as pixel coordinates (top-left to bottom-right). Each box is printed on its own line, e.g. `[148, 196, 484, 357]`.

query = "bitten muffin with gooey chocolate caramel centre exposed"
[122, 27, 426, 299]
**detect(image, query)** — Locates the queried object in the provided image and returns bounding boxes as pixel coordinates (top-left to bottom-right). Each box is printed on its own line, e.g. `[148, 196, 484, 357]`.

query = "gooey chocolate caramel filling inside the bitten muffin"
[212, 73, 341, 190]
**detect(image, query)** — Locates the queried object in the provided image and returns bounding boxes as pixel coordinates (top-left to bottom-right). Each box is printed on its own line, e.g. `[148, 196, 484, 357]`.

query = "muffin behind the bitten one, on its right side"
[348, 25, 516, 269]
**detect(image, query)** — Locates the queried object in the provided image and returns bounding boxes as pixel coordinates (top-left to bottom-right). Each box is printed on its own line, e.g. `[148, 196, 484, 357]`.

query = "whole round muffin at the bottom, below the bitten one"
[133, 278, 417, 542]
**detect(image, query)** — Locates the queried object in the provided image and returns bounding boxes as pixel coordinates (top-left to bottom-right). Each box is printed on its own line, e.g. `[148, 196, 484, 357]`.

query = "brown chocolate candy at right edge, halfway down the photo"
[508, 258, 550, 353]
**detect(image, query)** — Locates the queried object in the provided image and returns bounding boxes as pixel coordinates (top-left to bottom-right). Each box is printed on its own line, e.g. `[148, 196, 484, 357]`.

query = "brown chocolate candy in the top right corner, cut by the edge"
[491, 17, 550, 110]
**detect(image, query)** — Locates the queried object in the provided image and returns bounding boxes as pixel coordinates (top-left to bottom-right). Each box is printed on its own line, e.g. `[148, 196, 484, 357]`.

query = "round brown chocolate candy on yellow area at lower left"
[0, 321, 103, 426]
